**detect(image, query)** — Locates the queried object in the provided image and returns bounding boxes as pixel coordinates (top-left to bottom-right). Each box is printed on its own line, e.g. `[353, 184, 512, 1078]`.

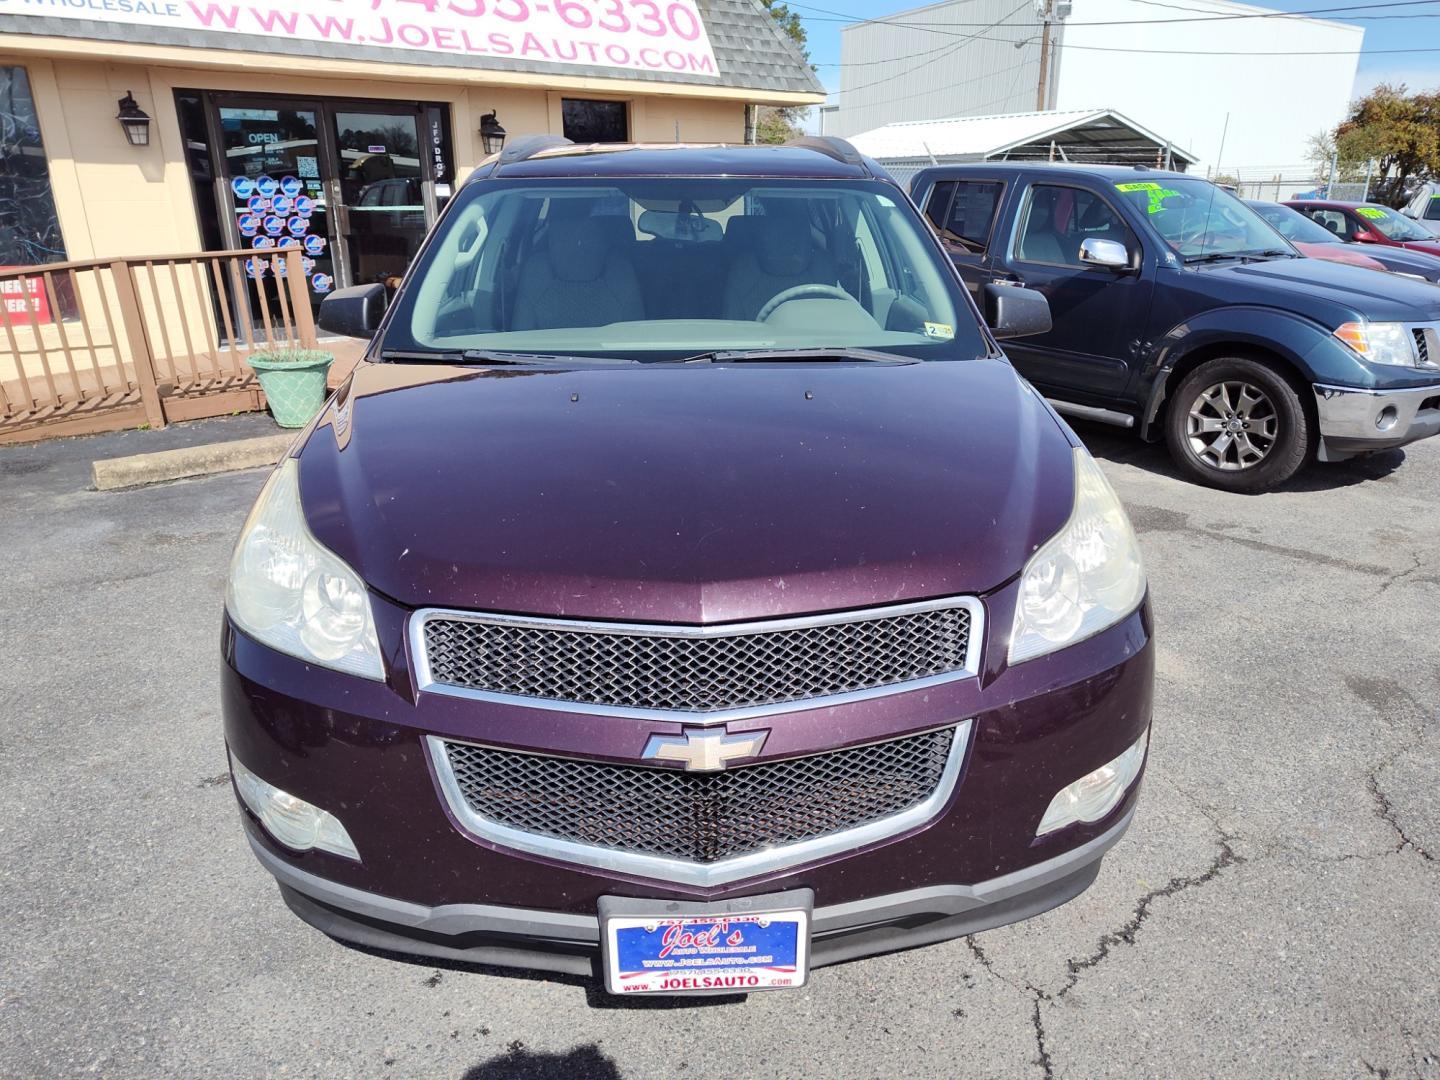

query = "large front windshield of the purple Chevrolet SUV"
[383, 177, 988, 360]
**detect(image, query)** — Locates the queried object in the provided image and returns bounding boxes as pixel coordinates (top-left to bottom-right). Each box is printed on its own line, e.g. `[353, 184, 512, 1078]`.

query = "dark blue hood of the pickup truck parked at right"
[1201, 259, 1440, 325]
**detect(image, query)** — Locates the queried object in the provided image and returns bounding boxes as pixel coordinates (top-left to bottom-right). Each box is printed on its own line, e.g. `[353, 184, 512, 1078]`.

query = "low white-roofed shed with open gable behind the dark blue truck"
[851, 109, 1195, 186]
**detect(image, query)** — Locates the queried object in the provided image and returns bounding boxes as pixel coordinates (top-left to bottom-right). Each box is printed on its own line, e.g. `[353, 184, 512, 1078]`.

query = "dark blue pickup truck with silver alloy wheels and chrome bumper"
[910, 161, 1440, 492]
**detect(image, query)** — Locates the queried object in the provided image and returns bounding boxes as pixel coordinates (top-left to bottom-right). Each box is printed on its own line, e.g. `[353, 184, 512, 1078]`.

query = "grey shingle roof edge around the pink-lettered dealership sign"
[0, 0, 825, 95]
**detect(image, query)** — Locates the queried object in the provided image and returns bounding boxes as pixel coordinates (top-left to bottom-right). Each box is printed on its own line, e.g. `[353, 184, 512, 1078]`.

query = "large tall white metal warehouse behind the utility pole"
[825, 0, 1365, 171]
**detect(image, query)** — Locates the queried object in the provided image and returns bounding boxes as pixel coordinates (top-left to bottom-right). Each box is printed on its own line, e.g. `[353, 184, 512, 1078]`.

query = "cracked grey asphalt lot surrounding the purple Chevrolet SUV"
[0, 416, 1440, 1080]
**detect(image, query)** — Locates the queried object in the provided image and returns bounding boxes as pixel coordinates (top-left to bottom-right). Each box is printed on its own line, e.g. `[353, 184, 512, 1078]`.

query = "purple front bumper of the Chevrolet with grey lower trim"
[222, 583, 1153, 973]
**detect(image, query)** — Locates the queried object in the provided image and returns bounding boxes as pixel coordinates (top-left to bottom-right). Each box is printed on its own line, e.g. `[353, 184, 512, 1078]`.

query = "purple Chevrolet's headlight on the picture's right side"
[1009, 448, 1145, 664]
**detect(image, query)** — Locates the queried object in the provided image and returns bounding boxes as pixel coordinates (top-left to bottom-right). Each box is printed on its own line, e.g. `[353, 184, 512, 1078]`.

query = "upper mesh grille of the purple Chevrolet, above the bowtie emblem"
[416, 600, 978, 713]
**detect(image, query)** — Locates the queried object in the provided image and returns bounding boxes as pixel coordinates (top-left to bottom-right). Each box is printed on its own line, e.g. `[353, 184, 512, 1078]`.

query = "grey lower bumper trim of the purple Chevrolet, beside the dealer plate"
[248, 804, 1135, 978]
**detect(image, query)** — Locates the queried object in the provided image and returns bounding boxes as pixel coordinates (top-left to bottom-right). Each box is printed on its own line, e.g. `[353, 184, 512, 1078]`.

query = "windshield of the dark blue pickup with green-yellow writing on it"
[1115, 176, 1295, 262]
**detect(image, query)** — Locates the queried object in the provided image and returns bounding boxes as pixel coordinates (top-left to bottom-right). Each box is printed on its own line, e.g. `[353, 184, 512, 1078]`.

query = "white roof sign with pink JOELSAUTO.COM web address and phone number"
[0, 0, 719, 78]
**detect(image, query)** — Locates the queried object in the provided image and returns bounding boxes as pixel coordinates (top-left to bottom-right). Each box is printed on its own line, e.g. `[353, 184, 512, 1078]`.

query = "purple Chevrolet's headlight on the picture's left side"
[225, 458, 384, 680]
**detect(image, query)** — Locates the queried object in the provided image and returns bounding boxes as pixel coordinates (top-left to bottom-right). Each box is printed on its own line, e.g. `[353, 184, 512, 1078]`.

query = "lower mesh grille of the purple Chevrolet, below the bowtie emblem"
[439, 727, 963, 865]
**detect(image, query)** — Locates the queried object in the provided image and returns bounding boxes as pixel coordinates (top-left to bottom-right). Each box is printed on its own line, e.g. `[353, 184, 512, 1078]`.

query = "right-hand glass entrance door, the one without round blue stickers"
[330, 105, 433, 287]
